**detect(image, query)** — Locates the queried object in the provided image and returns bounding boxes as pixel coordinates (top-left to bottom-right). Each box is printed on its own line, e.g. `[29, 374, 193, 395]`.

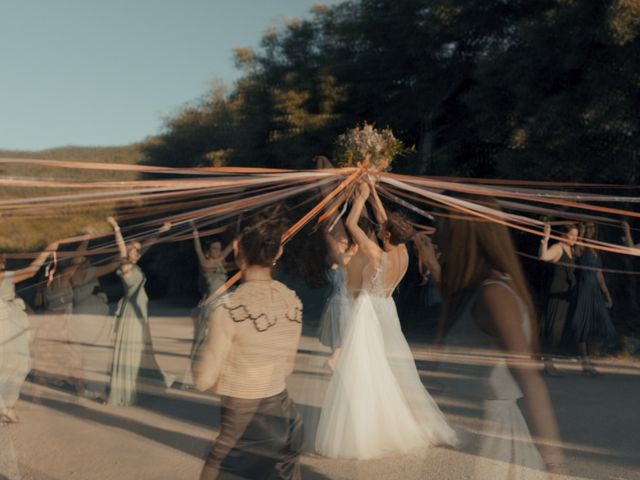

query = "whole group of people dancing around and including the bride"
[0, 167, 632, 480]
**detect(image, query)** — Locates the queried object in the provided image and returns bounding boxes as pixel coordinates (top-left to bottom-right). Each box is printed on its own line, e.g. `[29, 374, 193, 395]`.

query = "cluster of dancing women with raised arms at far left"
[0, 217, 181, 423]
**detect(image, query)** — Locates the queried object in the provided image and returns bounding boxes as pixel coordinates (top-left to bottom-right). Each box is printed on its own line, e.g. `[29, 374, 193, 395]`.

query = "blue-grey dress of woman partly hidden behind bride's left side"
[318, 267, 352, 349]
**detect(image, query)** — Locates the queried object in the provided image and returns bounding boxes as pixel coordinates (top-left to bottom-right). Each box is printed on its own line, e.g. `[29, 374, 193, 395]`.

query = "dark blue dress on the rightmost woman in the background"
[570, 250, 616, 342]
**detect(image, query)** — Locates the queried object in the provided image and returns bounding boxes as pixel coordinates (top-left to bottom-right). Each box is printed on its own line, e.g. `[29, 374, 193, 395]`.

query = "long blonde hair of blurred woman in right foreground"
[438, 199, 537, 346]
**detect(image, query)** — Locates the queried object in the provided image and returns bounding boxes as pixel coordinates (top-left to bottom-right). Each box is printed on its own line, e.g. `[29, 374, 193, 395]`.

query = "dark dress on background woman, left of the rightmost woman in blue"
[542, 249, 576, 353]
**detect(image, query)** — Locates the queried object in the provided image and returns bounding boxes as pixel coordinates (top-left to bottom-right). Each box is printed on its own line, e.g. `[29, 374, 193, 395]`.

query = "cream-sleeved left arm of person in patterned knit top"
[193, 307, 234, 391]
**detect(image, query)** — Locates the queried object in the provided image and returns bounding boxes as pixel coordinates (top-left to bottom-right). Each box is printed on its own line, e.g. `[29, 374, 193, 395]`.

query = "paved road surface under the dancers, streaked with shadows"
[0, 311, 640, 480]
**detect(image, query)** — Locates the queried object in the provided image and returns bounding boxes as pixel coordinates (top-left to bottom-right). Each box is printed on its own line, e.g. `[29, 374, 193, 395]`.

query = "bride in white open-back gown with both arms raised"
[315, 176, 457, 459]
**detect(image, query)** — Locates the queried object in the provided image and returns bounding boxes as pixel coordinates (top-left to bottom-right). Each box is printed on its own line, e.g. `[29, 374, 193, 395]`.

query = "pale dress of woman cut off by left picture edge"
[0, 271, 31, 409]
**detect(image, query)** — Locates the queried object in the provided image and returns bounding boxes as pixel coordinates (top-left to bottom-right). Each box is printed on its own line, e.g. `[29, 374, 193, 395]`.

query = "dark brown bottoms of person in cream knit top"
[200, 389, 303, 480]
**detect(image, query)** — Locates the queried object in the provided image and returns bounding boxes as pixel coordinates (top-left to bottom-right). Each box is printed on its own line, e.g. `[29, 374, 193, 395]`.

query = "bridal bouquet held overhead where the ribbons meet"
[335, 123, 410, 172]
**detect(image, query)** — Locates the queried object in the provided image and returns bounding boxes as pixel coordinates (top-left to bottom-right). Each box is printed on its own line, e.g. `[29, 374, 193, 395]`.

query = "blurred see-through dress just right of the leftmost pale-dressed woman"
[32, 278, 84, 380]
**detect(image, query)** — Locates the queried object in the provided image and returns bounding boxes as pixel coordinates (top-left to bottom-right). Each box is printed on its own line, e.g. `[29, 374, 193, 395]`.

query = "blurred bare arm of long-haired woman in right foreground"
[481, 284, 565, 470]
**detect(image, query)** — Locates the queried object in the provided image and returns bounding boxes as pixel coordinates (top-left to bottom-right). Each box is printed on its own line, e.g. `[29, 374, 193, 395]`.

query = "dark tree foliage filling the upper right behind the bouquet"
[145, 0, 640, 182]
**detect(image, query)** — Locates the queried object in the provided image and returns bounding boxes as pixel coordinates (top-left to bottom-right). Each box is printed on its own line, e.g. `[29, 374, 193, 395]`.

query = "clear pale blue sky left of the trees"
[0, 0, 339, 150]
